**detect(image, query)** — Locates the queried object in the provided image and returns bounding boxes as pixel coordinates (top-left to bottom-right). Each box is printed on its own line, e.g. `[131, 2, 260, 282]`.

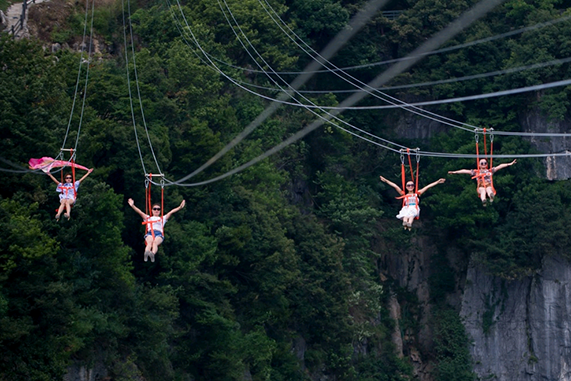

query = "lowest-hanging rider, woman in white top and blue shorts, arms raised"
[127, 198, 186, 262]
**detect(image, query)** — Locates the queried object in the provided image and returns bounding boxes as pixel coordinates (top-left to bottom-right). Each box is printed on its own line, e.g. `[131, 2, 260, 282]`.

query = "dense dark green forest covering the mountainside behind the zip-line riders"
[0, 0, 571, 381]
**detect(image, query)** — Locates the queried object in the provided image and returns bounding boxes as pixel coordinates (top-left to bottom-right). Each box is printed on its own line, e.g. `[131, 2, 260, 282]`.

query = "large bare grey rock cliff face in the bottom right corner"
[461, 257, 571, 381]
